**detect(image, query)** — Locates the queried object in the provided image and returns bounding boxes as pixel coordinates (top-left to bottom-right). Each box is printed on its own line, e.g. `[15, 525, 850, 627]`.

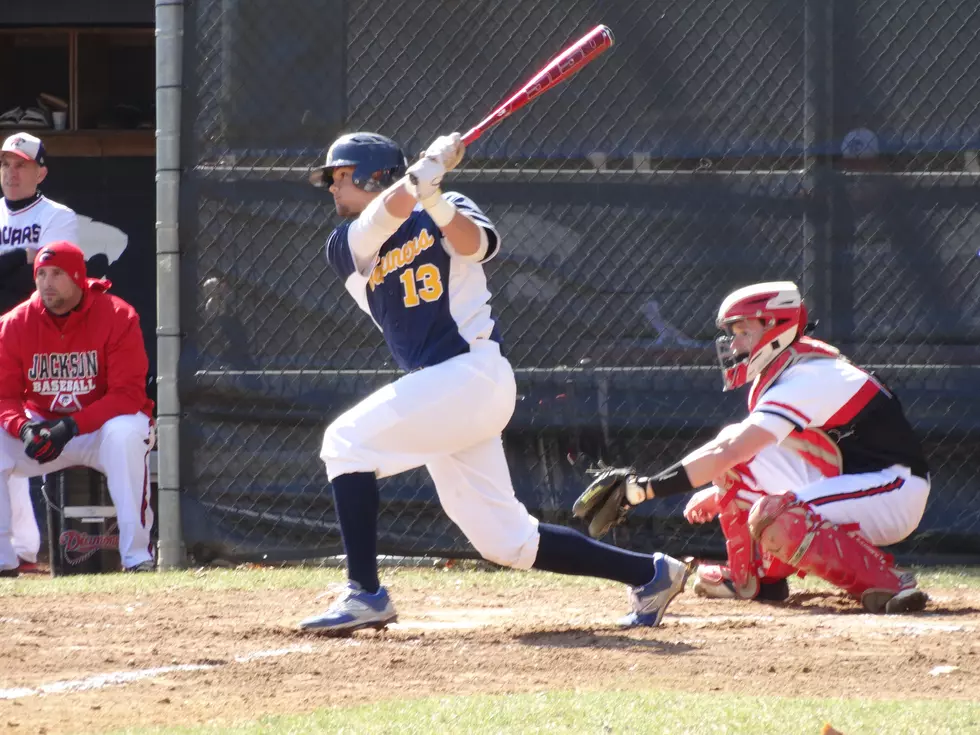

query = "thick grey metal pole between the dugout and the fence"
[155, 0, 185, 569]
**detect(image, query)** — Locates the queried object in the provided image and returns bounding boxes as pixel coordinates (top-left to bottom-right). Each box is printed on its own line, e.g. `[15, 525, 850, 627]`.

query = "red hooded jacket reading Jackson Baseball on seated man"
[0, 274, 153, 438]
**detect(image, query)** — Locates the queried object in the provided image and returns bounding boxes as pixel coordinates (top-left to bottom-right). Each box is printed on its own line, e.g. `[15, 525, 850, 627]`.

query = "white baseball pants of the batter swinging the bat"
[320, 340, 538, 569]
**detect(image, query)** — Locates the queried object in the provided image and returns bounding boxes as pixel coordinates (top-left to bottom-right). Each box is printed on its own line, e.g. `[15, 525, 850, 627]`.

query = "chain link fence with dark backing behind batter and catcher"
[180, 0, 980, 561]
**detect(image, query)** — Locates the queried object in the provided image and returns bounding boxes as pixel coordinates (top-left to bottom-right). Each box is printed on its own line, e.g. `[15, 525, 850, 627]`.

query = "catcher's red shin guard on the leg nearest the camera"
[749, 493, 916, 612]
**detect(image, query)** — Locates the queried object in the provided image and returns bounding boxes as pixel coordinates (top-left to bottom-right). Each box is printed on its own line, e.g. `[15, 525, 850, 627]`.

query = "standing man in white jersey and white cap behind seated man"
[0, 133, 78, 569]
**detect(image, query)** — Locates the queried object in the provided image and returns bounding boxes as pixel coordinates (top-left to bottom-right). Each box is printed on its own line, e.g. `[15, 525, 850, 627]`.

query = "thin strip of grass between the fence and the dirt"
[0, 564, 980, 597]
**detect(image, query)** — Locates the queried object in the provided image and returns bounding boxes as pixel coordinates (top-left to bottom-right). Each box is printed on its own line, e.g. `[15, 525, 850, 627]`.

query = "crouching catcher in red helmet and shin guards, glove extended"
[580, 281, 929, 613]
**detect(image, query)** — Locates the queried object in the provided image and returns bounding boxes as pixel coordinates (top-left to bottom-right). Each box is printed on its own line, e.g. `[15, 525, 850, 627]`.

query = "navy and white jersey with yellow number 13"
[327, 192, 500, 370]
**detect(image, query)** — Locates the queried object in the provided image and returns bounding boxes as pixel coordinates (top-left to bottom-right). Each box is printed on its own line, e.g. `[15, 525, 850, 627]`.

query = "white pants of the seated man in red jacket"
[0, 413, 153, 569]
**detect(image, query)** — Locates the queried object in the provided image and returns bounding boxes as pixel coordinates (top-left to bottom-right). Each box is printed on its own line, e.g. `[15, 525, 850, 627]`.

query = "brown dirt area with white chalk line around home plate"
[0, 577, 980, 733]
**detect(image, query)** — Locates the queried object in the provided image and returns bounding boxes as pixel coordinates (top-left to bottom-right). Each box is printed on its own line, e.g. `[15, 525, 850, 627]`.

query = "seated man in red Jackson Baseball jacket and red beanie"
[0, 242, 154, 576]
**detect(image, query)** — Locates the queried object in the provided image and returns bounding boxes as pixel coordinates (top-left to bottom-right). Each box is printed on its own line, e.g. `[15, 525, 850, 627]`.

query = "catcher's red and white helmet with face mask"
[715, 281, 807, 391]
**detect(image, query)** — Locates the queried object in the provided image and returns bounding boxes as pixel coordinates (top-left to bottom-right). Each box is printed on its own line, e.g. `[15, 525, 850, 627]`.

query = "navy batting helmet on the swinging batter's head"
[310, 133, 408, 192]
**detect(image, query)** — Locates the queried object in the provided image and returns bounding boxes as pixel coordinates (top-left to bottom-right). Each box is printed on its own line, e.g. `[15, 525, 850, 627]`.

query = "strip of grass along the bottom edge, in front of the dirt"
[111, 691, 980, 735]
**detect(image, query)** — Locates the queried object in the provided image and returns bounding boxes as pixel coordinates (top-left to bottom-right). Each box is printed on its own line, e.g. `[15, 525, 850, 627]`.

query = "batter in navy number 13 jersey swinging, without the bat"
[300, 133, 688, 635]
